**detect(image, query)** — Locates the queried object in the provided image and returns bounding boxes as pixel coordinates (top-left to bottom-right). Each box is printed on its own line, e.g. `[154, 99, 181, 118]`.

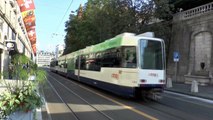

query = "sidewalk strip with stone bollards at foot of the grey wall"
[165, 83, 213, 100]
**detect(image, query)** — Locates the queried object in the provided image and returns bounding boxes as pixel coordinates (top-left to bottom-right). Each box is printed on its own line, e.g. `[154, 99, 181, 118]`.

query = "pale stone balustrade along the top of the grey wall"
[173, 2, 213, 21]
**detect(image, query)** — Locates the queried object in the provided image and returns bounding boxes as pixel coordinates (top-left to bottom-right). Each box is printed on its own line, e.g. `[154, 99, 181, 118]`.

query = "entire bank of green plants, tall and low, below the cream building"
[0, 54, 46, 118]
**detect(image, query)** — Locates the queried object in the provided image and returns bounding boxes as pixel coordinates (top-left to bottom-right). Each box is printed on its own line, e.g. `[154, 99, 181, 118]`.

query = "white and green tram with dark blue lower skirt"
[51, 33, 166, 97]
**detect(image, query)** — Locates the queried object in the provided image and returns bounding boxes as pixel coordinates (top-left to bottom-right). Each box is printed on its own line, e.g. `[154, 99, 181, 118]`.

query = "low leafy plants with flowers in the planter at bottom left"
[0, 83, 43, 118]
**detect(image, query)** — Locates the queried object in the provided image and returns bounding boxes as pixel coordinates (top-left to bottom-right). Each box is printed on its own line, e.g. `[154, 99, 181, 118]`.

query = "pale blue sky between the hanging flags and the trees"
[34, 0, 87, 52]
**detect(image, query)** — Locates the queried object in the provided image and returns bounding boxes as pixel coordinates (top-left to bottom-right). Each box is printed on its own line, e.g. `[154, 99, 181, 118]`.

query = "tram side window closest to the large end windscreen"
[122, 47, 137, 68]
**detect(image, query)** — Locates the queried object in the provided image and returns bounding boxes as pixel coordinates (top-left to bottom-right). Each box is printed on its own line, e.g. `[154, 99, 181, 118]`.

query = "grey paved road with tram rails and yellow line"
[43, 72, 213, 120]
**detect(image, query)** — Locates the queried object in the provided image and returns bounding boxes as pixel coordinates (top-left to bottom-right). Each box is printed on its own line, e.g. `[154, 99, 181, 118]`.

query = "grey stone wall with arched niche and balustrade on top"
[167, 2, 213, 85]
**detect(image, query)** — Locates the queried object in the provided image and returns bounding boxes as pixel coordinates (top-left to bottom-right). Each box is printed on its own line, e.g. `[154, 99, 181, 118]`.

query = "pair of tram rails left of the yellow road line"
[48, 73, 113, 120]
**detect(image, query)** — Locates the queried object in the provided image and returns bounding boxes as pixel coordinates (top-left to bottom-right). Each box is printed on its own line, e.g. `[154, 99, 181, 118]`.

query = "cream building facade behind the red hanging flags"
[0, 0, 34, 72]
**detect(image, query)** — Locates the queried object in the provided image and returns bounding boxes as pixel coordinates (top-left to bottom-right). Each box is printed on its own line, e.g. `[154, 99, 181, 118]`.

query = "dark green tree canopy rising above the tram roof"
[64, 0, 173, 54]
